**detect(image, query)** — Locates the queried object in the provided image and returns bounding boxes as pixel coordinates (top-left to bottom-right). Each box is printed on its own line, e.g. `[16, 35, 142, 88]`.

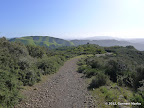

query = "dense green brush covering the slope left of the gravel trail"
[0, 37, 105, 108]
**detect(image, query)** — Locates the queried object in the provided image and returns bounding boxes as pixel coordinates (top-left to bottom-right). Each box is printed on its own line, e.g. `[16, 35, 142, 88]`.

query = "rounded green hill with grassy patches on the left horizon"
[9, 36, 74, 48]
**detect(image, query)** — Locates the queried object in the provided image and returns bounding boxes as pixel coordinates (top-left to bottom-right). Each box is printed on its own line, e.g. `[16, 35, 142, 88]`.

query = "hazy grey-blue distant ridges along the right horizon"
[71, 39, 144, 51]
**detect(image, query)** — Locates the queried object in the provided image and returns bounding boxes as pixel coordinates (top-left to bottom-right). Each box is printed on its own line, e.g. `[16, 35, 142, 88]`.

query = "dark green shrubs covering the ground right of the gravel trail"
[78, 46, 144, 108]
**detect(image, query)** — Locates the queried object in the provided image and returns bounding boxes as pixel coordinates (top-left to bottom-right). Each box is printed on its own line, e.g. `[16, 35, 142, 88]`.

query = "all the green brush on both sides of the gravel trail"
[0, 37, 144, 108]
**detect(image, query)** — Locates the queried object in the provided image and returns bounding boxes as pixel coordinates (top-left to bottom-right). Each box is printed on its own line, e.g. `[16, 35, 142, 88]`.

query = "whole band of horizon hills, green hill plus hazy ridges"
[9, 36, 144, 51]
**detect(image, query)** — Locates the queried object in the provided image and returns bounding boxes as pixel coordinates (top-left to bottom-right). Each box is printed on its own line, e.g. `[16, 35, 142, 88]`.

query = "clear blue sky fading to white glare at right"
[0, 0, 144, 39]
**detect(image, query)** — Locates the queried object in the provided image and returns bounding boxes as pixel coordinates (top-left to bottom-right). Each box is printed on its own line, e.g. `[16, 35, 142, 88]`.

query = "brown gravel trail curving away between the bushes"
[15, 58, 95, 108]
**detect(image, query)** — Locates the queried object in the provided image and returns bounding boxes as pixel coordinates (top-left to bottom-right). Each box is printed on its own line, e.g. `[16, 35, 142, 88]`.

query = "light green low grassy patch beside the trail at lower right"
[87, 77, 133, 108]
